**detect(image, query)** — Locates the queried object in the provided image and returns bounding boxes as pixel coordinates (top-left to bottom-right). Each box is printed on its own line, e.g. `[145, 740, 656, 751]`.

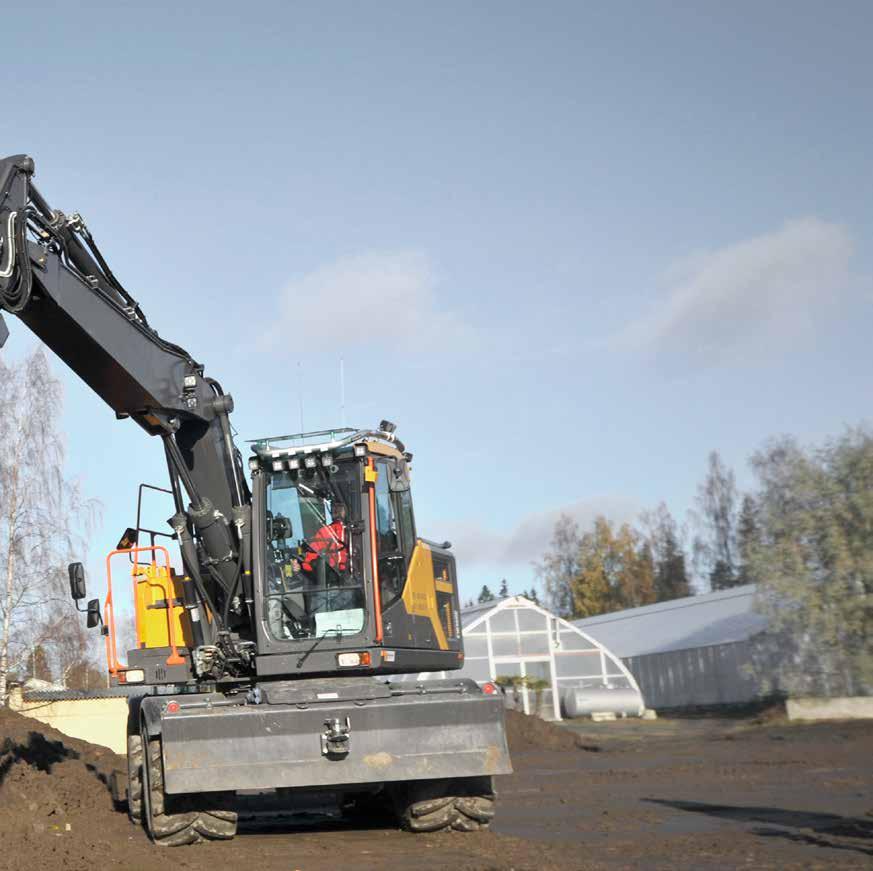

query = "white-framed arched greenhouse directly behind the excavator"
[409, 596, 645, 720]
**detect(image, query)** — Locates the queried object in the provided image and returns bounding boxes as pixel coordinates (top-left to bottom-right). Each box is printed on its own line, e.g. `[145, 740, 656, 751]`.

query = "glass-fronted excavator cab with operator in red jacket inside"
[249, 421, 463, 674]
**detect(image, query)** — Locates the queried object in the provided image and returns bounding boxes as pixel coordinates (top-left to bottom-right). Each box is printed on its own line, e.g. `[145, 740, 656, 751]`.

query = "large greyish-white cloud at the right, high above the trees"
[609, 218, 853, 364]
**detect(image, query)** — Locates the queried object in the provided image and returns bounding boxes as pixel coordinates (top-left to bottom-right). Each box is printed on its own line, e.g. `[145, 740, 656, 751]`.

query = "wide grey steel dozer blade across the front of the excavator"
[150, 681, 512, 793]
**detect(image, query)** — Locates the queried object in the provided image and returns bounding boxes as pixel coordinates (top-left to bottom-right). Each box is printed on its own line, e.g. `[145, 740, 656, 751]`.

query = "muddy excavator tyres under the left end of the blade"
[147, 738, 237, 847]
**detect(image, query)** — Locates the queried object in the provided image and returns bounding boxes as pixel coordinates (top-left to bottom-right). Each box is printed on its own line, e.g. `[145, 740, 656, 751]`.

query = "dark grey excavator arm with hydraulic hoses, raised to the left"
[0, 155, 251, 640]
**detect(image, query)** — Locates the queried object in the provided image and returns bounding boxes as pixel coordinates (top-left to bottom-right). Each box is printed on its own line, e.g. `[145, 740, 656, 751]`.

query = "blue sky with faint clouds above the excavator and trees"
[0, 0, 873, 599]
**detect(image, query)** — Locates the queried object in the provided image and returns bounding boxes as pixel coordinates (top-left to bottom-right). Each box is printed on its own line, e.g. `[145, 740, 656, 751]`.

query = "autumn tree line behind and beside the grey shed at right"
[536, 426, 873, 695]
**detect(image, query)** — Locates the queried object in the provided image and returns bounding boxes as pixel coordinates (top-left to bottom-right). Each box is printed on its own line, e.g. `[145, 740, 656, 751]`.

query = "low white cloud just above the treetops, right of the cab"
[439, 496, 640, 571]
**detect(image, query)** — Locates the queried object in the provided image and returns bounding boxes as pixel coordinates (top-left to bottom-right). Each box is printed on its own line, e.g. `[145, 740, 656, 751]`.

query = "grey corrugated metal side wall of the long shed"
[624, 641, 762, 710]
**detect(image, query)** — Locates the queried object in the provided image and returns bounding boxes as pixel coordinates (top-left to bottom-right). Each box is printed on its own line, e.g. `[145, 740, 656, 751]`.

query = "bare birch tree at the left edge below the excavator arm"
[0, 348, 98, 705]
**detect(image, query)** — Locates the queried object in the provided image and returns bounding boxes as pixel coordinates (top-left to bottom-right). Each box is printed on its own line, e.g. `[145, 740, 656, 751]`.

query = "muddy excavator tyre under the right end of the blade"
[393, 777, 495, 832]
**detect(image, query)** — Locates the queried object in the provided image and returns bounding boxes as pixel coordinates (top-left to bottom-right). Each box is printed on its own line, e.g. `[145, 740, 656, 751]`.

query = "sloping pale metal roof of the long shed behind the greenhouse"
[573, 584, 767, 659]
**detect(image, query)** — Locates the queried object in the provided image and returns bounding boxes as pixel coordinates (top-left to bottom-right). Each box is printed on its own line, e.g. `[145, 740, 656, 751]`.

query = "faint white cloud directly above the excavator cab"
[268, 252, 475, 352]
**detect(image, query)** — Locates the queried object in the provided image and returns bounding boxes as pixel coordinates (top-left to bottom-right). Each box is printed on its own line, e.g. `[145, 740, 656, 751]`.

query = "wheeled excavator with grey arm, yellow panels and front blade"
[0, 154, 512, 846]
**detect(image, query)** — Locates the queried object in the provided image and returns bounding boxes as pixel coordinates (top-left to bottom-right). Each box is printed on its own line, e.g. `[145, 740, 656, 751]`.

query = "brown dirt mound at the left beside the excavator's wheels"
[0, 709, 147, 871]
